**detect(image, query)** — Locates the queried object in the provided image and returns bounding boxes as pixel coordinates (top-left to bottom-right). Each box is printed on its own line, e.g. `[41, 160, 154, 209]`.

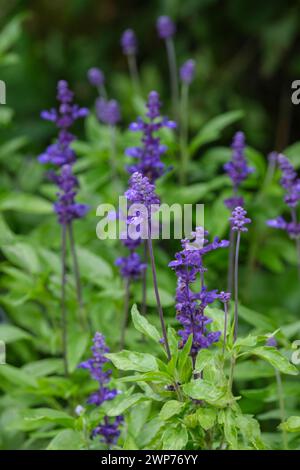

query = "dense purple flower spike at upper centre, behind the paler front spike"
[126, 91, 176, 182]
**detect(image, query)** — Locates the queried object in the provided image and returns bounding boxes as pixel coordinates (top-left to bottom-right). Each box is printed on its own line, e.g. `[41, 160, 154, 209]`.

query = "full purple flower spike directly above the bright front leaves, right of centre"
[169, 227, 229, 358]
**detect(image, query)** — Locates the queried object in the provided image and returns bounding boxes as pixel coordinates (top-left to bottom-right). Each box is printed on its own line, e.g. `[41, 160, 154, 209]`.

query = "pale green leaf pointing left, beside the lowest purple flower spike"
[106, 350, 158, 372]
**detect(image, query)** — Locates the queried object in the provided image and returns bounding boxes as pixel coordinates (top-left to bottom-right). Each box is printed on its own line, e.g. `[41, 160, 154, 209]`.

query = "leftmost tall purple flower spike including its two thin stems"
[38, 80, 88, 375]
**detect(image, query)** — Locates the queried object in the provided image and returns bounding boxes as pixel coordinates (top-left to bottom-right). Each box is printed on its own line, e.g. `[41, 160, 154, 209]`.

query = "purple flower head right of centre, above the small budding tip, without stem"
[224, 132, 253, 210]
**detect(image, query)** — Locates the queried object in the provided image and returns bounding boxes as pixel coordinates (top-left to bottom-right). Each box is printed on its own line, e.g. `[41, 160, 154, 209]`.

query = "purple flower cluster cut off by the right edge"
[267, 154, 300, 239]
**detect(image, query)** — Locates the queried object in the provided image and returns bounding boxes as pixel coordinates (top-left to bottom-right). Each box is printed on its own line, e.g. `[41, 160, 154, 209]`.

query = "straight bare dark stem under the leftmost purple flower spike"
[61, 225, 69, 376]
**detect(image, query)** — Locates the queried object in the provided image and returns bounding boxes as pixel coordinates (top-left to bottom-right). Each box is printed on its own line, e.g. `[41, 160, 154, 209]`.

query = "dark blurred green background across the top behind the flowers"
[0, 0, 300, 152]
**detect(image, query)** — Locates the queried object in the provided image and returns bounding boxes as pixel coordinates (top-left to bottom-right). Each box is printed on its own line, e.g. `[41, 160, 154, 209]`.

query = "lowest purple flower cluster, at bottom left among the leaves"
[78, 333, 123, 444]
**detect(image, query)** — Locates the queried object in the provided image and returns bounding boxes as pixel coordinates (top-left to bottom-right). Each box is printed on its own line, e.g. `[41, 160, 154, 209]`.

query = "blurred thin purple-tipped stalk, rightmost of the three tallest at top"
[180, 59, 196, 184]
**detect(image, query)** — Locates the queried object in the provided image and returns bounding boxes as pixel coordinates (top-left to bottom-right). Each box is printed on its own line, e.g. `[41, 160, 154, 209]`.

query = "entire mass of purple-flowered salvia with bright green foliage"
[0, 12, 300, 451]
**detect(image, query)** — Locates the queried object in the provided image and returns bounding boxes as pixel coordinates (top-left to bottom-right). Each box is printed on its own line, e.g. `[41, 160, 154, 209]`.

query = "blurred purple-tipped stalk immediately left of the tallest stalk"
[121, 29, 141, 95]
